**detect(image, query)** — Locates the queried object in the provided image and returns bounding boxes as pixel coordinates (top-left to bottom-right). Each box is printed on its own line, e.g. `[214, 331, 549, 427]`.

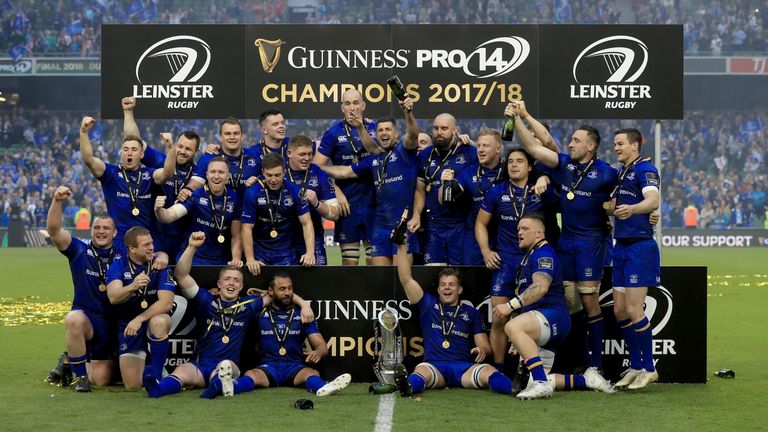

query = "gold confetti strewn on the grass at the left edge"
[0, 296, 72, 327]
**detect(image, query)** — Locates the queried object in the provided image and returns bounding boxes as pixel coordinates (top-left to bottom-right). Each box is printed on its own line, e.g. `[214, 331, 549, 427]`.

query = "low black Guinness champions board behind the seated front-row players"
[168, 266, 707, 383]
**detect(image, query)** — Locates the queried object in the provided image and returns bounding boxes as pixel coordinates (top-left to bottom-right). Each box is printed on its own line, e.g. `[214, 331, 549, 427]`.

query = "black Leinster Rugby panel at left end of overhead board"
[101, 25, 245, 119]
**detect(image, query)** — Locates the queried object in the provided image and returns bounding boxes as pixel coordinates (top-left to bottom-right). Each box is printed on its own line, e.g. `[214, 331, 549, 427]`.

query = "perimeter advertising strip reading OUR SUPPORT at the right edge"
[661, 228, 768, 248]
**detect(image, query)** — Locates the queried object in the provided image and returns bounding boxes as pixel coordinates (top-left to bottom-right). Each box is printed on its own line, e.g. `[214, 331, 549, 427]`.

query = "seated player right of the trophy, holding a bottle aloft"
[395, 241, 512, 396]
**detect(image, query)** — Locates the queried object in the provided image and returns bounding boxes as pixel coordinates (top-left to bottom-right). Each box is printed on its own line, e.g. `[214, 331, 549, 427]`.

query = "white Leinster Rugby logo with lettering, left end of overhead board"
[133, 35, 213, 108]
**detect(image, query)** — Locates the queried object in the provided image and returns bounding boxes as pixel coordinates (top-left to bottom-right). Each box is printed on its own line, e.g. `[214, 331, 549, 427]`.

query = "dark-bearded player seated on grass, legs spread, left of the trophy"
[200, 274, 352, 398]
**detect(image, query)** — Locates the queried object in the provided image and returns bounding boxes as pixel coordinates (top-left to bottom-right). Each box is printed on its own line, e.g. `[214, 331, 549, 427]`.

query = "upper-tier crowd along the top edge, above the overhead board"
[0, 0, 768, 58]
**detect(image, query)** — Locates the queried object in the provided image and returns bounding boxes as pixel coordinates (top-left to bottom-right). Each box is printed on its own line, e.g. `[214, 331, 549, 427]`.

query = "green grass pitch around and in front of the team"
[0, 248, 768, 432]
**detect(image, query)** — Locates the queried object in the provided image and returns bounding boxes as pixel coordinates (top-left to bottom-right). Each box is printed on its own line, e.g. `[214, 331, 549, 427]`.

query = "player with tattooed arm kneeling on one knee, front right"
[493, 214, 614, 399]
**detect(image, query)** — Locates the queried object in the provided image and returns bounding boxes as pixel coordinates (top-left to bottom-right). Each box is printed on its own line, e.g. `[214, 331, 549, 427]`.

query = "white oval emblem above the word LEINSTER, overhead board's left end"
[136, 35, 211, 83]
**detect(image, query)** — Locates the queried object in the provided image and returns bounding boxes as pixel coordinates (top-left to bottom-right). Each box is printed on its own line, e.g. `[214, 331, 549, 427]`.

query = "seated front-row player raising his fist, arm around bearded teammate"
[142, 231, 314, 397]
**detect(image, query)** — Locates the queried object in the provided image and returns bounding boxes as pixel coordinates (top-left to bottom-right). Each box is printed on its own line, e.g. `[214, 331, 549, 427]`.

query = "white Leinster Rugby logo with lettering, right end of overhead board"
[570, 35, 651, 109]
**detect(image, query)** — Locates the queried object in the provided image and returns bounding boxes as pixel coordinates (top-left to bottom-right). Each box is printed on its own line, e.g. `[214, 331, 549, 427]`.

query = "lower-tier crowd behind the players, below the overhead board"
[0, 108, 768, 229]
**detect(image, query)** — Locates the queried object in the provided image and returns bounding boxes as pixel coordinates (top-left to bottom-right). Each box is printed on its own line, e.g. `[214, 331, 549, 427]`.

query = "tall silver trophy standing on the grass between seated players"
[370, 307, 404, 393]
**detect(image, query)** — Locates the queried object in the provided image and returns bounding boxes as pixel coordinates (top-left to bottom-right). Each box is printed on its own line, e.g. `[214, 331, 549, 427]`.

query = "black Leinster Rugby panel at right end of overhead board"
[540, 25, 683, 119]
